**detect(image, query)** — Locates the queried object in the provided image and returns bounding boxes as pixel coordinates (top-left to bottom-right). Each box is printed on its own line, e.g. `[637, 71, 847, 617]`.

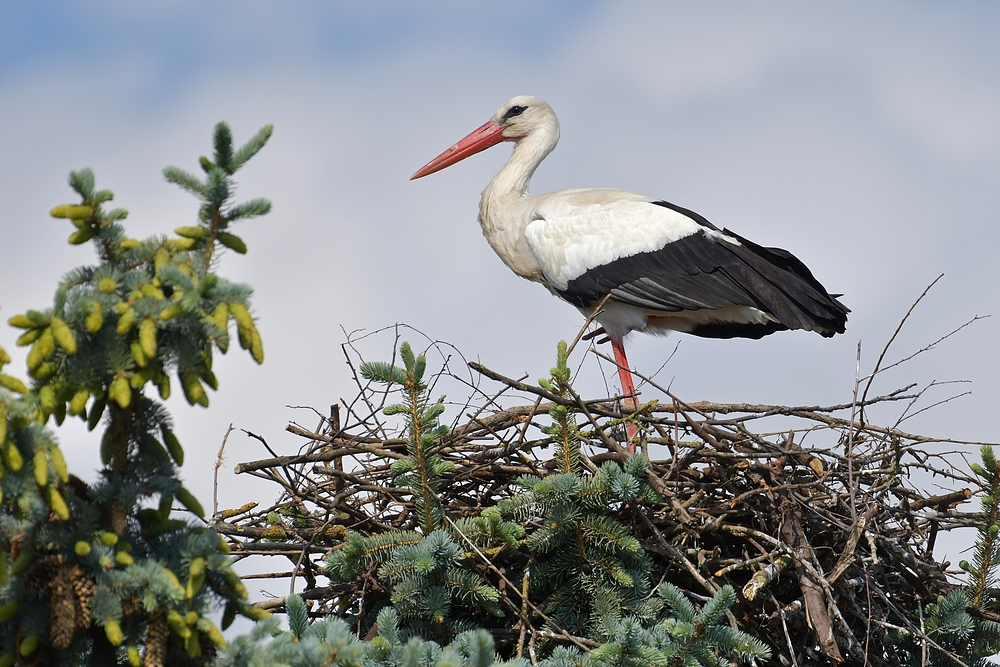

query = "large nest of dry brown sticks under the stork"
[212, 326, 980, 665]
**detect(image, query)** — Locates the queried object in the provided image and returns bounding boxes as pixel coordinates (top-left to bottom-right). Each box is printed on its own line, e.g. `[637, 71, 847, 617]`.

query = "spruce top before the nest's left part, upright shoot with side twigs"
[326, 343, 523, 641]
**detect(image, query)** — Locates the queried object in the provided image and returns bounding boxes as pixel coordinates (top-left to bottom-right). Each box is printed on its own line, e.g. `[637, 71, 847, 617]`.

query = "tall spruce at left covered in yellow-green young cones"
[0, 123, 271, 667]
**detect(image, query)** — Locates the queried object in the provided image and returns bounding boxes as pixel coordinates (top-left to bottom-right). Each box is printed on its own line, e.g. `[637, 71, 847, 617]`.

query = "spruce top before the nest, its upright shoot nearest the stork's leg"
[498, 342, 659, 635]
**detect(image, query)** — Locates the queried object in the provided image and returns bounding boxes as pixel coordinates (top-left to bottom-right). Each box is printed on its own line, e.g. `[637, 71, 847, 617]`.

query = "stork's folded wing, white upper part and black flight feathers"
[527, 200, 849, 338]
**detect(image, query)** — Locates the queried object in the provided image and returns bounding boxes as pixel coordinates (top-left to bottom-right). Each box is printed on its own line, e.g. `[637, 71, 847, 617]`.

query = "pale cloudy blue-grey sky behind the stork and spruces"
[0, 0, 1000, 604]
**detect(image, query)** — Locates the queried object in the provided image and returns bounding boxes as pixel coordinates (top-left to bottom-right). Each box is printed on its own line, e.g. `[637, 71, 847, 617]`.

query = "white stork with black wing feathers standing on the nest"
[411, 96, 850, 438]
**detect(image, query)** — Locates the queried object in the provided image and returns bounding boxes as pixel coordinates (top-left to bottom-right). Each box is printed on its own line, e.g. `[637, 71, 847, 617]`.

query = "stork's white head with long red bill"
[410, 95, 559, 181]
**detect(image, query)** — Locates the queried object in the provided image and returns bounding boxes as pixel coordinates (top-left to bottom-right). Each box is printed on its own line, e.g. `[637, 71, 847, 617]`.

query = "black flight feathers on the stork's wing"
[560, 197, 849, 338]
